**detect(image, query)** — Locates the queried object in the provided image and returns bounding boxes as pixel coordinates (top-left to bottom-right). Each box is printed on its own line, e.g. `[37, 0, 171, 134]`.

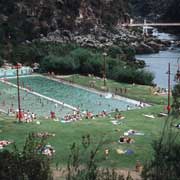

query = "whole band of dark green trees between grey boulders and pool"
[0, 42, 154, 85]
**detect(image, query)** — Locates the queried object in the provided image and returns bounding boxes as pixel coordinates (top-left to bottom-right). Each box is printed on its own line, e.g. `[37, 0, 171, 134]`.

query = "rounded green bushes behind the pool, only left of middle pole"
[40, 48, 102, 75]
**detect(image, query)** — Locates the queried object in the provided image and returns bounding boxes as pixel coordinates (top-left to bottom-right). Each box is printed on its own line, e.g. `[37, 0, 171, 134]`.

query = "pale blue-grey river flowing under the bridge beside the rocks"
[136, 33, 180, 88]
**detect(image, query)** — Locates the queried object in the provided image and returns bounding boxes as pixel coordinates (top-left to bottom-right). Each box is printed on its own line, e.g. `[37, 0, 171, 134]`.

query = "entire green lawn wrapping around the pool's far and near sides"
[0, 75, 176, 171]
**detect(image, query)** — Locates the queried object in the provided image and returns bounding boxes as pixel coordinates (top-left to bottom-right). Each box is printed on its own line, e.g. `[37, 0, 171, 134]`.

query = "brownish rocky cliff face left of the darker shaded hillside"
[0, 0, 128, 41]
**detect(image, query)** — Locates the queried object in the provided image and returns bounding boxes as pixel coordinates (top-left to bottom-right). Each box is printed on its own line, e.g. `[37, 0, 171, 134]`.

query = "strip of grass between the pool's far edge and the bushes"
[64, 75, 167, 105]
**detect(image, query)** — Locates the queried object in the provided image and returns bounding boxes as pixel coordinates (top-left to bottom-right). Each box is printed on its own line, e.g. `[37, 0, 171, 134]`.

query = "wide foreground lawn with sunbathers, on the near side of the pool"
[0, 105, 174, 168]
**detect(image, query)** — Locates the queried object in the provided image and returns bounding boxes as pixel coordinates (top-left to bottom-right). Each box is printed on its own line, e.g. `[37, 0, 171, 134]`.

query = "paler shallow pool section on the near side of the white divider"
[0, 83, 72, 117]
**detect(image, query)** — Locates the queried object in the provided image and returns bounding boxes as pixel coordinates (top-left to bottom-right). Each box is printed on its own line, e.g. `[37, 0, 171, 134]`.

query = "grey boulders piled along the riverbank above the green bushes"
[41, 26, 171, 54]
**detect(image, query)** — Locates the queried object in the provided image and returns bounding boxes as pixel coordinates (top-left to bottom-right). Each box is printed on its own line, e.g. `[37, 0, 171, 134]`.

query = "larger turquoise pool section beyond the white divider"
[9, 76, 135, 114]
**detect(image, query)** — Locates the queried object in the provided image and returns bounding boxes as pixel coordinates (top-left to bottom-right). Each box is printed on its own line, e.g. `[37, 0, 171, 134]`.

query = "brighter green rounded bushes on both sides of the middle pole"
[38, 44, 154, 85]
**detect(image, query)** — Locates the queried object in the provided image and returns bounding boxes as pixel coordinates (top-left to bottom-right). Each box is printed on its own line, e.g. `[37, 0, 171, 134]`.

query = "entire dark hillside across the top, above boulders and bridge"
[0, 0, 180, 42]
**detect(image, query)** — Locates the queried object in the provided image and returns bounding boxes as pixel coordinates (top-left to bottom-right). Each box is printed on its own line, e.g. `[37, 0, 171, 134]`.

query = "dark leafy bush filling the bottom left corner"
[0, 134, 52, 180]
